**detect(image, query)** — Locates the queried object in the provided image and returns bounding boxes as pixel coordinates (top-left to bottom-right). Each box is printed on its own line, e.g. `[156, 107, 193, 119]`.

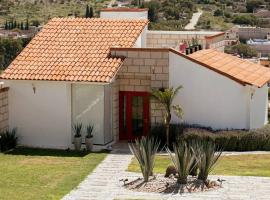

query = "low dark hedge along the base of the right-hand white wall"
[151, 125, 270, 151]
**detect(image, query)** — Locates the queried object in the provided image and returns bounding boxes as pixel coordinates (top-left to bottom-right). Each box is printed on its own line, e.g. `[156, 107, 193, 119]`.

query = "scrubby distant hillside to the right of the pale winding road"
[197, 0, 270, 31]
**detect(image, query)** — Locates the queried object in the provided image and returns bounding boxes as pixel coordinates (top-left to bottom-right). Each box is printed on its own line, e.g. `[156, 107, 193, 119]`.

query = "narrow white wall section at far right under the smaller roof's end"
[250, 84, 268, 129]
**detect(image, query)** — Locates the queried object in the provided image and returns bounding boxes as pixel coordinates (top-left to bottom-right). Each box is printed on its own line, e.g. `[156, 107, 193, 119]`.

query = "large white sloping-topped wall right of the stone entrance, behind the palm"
[169, 52, 252, 129]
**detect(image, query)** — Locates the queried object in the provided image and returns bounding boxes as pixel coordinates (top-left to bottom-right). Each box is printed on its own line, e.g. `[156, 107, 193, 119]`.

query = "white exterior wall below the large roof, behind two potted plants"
[5, 81, 113, 149]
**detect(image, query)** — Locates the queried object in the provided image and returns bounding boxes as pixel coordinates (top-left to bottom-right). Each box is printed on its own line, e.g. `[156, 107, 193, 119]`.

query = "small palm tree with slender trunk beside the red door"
[152, 86, 182, 146]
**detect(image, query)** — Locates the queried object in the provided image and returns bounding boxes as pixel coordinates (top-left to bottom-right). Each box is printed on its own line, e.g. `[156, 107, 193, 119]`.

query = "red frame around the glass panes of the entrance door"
[119, 91, 150, 140]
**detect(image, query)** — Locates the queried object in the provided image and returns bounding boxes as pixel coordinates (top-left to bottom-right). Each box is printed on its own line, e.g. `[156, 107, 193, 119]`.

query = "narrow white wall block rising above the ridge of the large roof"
[100, 10, 148, 19]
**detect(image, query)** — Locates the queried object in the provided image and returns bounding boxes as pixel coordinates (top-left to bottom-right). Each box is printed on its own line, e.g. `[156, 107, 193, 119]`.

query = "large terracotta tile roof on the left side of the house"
[0, 18, 148, 82]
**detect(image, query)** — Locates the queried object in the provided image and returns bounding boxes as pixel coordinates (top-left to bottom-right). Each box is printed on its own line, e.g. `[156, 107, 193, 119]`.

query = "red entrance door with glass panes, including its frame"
[119, 92, 150, 140]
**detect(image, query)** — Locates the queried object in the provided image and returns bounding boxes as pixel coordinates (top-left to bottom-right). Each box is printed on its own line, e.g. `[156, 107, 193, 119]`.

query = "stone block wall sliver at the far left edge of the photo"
[0, 87, 9, 132]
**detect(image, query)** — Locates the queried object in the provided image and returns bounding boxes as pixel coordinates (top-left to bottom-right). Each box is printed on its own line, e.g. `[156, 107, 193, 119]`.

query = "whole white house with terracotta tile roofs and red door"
[1, 8, 270, 149]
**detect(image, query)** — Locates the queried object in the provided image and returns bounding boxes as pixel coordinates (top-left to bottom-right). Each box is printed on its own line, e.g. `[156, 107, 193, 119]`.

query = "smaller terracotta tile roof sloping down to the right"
[187, 49, 270, 87]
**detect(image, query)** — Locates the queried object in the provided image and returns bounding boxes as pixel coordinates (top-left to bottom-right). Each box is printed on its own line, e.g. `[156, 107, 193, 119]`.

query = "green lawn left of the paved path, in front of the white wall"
[0, 148, 107, 200]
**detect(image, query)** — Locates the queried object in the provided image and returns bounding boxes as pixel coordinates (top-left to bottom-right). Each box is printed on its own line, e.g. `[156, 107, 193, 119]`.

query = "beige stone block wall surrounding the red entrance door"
[111, 48, 169, 141]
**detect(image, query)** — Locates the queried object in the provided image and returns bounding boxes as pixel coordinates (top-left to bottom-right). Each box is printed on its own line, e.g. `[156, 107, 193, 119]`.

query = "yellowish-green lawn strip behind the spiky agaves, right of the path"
[128, 154, 270, 177]
